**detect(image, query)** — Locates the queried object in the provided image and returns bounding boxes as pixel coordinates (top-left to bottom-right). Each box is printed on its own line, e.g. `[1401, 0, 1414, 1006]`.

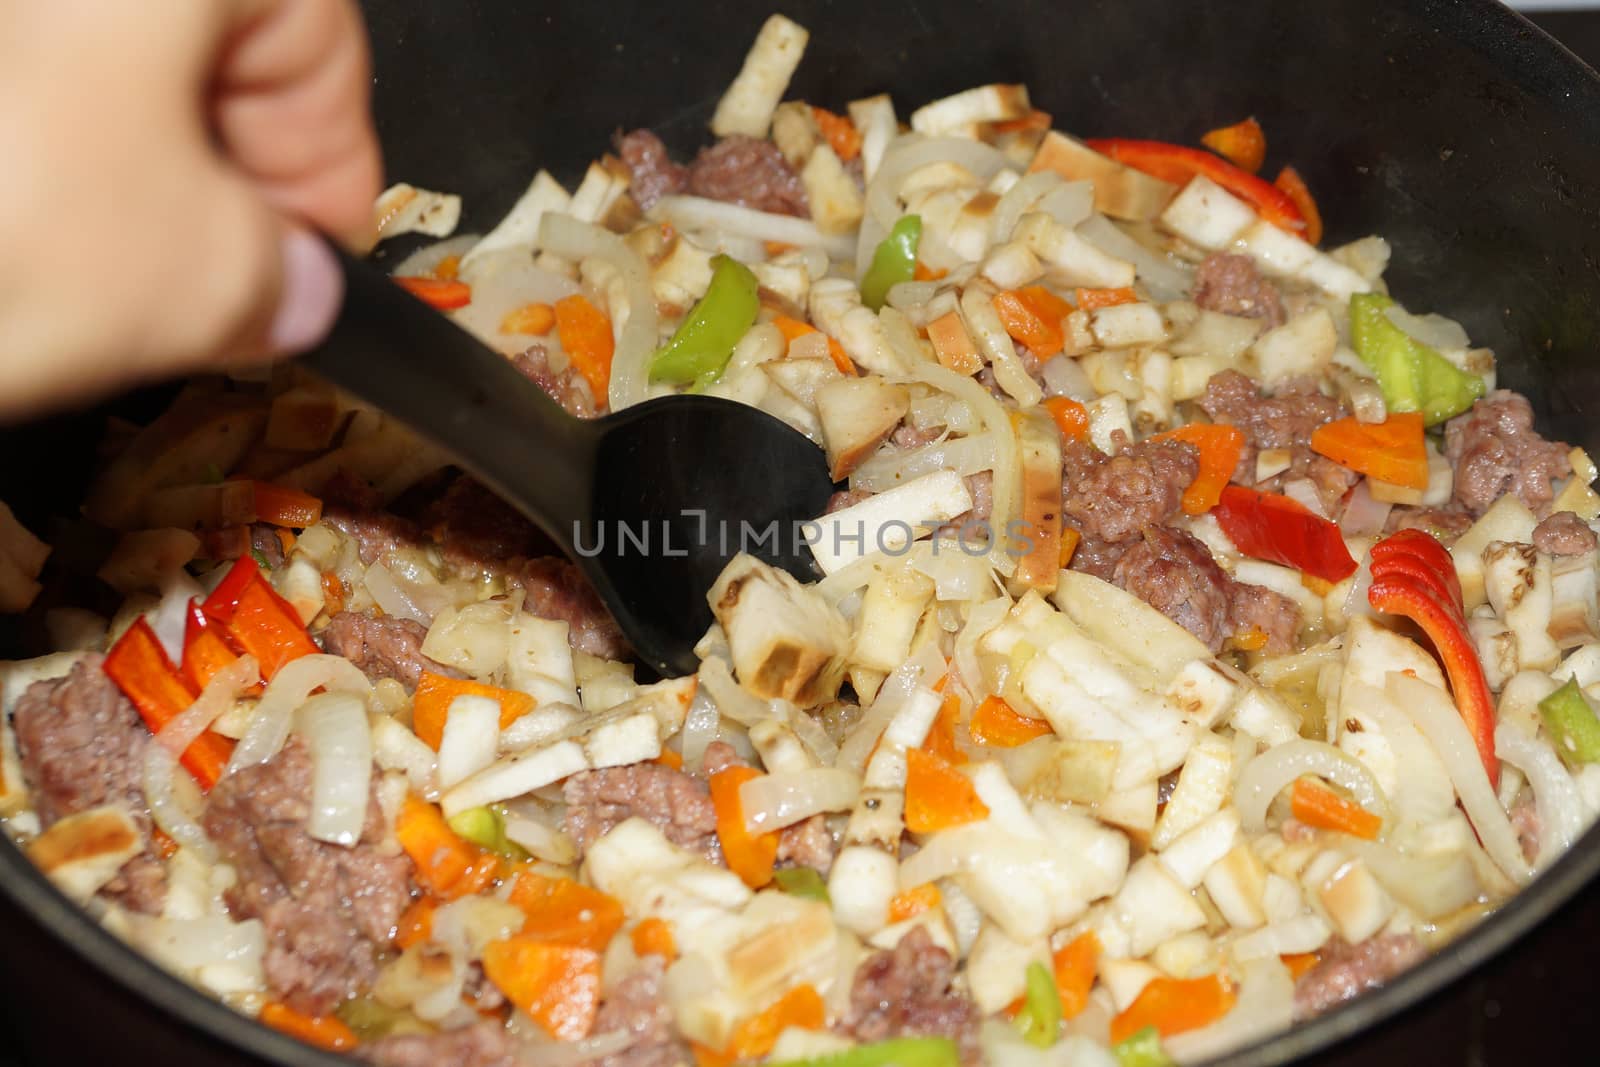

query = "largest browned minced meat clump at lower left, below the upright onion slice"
[203, 737, 411, 1016]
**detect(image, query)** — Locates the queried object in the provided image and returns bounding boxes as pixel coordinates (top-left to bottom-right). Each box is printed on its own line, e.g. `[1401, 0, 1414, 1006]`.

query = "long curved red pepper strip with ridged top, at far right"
[1366, 530, 1499, 787]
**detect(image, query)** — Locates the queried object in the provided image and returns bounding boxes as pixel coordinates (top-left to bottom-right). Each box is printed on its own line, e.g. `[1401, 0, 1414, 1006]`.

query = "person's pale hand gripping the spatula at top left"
[0, 0, 381, 421]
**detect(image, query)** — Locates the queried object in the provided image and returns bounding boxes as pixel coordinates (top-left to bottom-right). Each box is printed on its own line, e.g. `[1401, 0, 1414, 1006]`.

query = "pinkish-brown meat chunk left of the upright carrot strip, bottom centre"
[562, 763, 722, 864]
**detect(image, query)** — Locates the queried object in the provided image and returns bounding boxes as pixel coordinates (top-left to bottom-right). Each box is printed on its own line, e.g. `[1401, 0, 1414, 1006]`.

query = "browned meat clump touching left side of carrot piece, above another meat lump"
[1061, 431, 1200, 544]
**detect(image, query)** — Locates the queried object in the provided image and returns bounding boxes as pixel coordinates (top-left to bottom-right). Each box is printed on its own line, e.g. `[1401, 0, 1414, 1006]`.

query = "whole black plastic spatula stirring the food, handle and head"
[301, 247, 832, 675]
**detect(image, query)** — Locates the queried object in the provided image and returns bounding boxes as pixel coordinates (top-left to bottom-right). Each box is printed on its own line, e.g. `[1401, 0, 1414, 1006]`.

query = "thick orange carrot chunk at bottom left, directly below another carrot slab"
[483, 934, 600, 1041]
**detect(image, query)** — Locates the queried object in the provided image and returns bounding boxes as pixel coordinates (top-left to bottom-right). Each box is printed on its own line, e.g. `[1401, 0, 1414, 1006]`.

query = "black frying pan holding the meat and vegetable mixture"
[0, 0, 1600, 1067]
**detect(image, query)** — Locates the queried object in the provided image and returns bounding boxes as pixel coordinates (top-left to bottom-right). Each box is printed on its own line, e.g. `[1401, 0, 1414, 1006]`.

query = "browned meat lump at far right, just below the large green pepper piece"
[1445, 389, 1571, 515]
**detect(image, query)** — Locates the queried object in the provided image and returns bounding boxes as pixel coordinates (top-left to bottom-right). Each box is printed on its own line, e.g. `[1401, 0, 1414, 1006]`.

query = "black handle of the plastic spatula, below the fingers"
[301, 250, 597, 550]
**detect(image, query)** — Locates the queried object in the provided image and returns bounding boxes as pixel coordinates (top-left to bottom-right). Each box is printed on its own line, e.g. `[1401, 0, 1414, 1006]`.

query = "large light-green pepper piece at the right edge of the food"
[1350, 293, 1483, 426]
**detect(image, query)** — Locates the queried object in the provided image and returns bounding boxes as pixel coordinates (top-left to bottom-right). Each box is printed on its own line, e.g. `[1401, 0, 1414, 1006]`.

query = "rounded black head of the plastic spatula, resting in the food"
[570, 397, 834, 675]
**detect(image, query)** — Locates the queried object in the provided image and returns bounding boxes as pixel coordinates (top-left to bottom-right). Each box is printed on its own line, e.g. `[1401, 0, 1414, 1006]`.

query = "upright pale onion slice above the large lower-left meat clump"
[299, 693, 373, 846]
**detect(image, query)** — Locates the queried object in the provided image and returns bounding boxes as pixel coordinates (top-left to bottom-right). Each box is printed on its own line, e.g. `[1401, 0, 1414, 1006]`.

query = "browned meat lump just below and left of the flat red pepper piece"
[1110, 526, 1299, 653]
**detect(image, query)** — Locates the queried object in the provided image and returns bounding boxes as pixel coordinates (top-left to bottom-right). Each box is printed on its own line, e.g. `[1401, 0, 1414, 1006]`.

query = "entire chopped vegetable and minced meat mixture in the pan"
[0, 18, 1600, 1067]
